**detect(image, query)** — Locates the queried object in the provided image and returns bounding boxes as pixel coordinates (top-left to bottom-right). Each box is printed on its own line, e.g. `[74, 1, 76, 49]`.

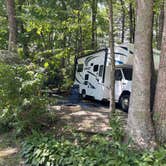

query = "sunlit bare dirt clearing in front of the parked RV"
[50, 99, 127, 133]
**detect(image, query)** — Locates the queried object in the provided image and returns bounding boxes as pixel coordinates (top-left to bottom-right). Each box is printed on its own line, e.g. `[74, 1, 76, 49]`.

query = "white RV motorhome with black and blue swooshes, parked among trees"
[74, 44, 160, 110]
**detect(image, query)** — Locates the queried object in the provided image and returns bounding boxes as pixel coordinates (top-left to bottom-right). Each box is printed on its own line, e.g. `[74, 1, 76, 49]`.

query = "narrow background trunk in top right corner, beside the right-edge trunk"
[157, 1, 164, 50]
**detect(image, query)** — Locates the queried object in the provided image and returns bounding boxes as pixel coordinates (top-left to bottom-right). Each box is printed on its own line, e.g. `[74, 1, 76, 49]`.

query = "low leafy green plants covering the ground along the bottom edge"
[22, 133, 166, 166]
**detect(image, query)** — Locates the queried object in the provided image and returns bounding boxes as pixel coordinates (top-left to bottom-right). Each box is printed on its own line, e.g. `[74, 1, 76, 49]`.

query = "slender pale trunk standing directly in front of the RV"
[109, 0, 115, 114]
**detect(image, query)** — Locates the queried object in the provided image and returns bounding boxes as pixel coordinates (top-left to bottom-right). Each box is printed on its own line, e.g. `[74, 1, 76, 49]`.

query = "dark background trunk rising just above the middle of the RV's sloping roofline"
[92, 0, 97, 50]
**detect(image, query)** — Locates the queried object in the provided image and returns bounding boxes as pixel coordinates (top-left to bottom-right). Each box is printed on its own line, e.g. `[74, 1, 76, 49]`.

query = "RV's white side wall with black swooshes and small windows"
[75, 49, 107, 100]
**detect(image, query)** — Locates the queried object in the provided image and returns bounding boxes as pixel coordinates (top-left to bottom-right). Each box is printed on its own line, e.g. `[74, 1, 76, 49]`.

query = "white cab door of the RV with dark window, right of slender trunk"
[115, 69, 123, 102]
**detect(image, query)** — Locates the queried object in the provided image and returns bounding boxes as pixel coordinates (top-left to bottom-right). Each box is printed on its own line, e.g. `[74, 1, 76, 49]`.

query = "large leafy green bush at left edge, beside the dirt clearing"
[0, 64, 47, 132]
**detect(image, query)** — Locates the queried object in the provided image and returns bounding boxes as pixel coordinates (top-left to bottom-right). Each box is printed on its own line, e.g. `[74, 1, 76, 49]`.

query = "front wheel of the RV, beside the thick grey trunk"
[120, 94, 130, 112]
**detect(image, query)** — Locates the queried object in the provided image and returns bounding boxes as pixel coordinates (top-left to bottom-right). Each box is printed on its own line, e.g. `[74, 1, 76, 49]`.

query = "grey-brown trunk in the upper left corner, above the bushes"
[7, 0, 17, 51]
